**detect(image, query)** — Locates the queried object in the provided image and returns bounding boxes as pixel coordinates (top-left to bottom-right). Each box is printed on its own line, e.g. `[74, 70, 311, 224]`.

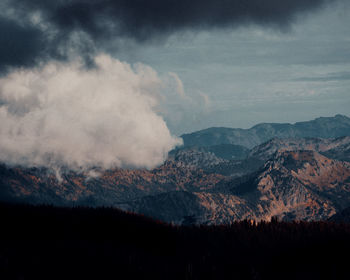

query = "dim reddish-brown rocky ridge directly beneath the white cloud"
[0, 161, 224, 206]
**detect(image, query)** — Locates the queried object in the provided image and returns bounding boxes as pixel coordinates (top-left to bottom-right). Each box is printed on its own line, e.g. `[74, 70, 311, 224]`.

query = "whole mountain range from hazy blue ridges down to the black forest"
[0, 115, 350, 224]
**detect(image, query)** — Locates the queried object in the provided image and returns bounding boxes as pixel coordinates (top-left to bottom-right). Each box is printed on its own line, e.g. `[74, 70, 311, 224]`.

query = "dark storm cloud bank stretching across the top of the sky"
[0, 0, 337, 70]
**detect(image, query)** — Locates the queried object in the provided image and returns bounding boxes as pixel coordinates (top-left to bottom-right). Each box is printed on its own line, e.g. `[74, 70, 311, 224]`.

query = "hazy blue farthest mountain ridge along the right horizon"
[181, 115, 350, 148]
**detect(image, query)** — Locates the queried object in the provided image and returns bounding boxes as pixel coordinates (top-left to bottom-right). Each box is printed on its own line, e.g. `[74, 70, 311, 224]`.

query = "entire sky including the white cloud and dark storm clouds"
[0, 0, 350, 169]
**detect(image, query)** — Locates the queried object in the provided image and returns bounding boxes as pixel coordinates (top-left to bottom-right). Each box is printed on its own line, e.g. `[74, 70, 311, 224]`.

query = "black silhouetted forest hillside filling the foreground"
[0, 204, 350, 279]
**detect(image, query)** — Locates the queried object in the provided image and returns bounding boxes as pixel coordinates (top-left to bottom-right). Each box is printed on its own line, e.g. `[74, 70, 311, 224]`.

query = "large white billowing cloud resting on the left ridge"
[0, 55, 181, 170]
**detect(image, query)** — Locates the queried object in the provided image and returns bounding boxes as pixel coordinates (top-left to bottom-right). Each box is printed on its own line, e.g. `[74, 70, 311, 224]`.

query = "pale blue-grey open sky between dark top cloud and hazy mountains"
[114, 0, 350, 134]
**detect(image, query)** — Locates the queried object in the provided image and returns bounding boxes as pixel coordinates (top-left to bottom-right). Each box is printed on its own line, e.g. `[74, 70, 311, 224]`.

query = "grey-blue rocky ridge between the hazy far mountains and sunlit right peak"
[172, 136, 350, 177]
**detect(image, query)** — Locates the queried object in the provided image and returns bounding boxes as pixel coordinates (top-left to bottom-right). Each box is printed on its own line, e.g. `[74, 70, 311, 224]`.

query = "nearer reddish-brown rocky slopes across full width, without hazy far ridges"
[1, 148, 350, 224]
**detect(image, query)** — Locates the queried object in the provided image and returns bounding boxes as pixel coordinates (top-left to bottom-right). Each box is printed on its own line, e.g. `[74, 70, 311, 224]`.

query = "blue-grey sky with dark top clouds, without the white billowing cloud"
[0, 0, 350, 135]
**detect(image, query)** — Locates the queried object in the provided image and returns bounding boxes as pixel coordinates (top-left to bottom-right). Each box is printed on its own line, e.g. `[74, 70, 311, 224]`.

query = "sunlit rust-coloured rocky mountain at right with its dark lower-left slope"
[124, 151, 350, 224]
